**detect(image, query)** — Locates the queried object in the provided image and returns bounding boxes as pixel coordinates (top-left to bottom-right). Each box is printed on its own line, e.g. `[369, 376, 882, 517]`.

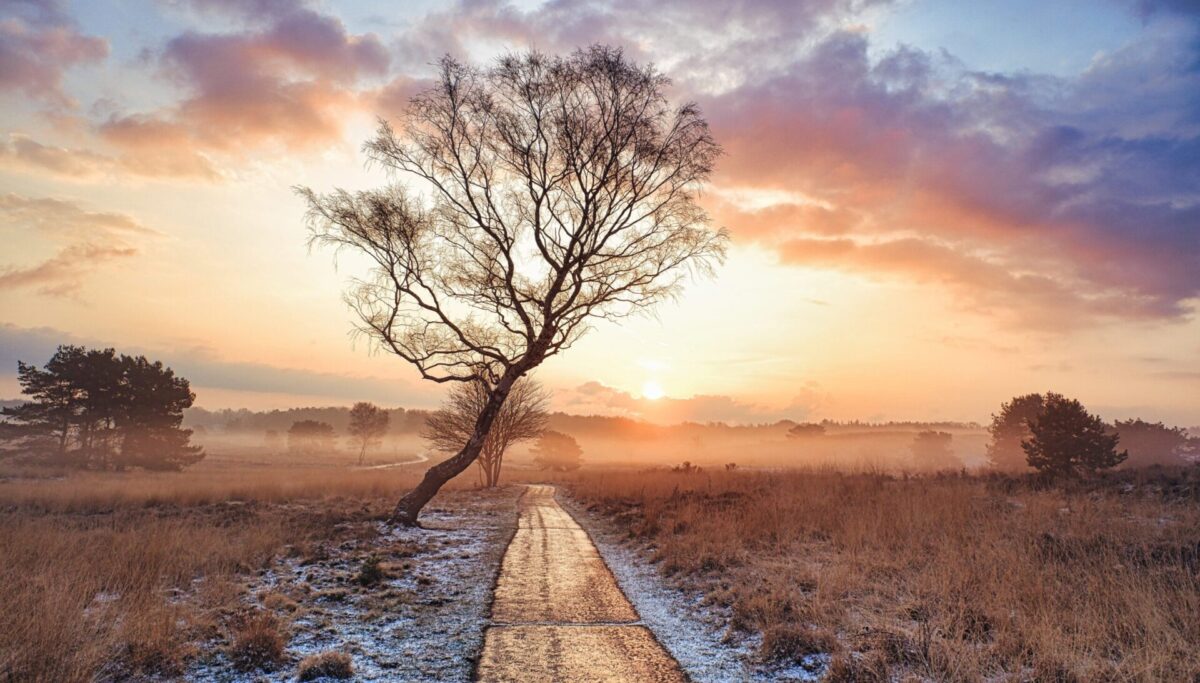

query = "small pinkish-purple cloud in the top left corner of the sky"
[0, 0, 108, 108]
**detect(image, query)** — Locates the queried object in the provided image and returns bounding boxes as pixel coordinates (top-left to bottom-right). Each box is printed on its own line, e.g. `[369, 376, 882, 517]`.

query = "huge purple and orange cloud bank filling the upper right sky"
[357, 0, 1200, 328]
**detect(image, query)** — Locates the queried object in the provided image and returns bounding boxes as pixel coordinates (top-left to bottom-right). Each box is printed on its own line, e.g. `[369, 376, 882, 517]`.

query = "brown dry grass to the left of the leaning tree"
[0, 467, 458, 683]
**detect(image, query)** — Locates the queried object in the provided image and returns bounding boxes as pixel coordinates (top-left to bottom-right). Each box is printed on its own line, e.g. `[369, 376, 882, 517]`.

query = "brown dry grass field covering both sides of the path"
[9, 456, 1200, 682]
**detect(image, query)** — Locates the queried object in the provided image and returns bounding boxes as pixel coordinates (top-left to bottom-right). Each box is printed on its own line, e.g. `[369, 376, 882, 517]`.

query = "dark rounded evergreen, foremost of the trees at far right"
[1021, 394, 1129, 477]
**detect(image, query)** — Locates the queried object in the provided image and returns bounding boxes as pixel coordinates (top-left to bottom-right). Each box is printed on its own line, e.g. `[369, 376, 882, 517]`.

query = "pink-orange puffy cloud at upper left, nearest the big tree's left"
[100, 0, 390, 156]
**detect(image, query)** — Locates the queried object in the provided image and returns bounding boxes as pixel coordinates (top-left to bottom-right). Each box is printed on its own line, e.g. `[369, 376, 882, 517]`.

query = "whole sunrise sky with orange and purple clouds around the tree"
[0, 0, 1200, 425]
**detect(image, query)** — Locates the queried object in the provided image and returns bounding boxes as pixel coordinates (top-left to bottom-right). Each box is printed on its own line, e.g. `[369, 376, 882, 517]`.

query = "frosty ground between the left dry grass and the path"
[187, 487, 522, 683]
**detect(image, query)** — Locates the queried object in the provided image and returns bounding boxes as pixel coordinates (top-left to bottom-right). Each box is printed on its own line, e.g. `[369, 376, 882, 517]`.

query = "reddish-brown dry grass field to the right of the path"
[572, 468, 1200, 681]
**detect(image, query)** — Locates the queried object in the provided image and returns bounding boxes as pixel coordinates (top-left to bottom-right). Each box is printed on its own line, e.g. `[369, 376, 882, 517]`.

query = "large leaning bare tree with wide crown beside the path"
[300, 46, 727, 525]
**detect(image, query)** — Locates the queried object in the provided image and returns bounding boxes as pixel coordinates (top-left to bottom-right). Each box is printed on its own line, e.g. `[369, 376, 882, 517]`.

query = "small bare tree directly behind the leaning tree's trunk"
[421, 377, 547, 489]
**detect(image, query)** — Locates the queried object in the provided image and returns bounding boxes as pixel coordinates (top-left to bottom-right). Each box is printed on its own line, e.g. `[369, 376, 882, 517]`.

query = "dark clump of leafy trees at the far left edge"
[0, 346, 204, 471]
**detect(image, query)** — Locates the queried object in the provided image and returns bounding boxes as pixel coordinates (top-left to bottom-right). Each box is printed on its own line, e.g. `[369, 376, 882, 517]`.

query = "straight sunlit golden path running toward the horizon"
[478, 486, 686, 683]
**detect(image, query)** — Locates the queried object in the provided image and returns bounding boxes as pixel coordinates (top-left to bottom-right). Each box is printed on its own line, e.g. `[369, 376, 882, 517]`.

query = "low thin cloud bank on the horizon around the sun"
[553, 382, 827, 424]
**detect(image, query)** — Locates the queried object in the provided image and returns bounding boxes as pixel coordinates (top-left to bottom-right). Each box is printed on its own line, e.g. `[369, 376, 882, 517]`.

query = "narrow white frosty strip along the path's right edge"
[559, 493, 829, 683]
